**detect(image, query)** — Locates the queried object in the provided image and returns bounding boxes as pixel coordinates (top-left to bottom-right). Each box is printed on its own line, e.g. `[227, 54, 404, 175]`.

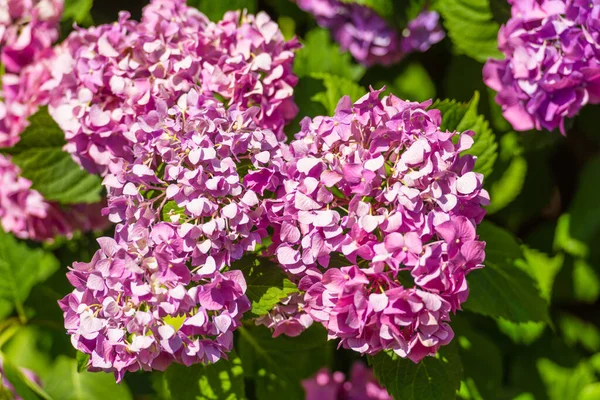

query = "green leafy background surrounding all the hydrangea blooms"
[0, 0, 600, 400]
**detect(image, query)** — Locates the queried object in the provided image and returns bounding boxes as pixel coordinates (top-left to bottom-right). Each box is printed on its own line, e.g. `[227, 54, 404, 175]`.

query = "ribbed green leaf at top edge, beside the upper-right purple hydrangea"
[436, 0, 503, 62]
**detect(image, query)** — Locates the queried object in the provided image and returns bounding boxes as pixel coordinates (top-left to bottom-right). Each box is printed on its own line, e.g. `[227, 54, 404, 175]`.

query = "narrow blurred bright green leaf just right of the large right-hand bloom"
[487, 132, 527, 214]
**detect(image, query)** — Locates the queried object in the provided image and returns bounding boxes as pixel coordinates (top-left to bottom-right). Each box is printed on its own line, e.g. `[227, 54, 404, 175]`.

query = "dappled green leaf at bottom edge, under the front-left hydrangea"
[157, 352, 246, 400]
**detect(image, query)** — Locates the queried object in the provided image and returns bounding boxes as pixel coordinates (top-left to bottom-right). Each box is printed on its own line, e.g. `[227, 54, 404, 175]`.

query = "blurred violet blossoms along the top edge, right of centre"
[295, 0, 445, 66]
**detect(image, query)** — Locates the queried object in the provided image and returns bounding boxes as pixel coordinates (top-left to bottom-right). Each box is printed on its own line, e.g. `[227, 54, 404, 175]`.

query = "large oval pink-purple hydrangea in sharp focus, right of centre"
[267, 90, 489, 362]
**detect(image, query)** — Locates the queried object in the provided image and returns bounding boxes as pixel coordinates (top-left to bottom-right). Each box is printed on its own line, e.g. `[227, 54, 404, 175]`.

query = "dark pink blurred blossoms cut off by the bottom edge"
[302, 362, 392, 400]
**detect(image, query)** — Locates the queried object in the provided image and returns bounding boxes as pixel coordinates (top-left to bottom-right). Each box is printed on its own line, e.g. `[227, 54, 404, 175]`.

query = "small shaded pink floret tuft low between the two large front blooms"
[255, 293, 313, 337]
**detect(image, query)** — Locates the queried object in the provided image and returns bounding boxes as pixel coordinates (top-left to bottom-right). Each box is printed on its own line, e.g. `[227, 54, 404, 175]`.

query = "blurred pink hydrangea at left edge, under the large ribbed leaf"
[0, 154, 106, 241]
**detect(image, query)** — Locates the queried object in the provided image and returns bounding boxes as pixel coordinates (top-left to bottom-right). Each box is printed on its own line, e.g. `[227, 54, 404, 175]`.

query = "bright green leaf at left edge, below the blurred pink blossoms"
[0, 231, 59, 320]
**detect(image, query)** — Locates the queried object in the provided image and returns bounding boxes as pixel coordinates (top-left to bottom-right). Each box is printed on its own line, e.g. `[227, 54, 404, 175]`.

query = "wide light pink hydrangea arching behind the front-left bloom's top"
[50, 0, 299, 174]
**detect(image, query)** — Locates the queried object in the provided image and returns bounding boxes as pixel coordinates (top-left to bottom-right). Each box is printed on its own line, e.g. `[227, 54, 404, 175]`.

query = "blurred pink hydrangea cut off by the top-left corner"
[0, 0, 63, 147]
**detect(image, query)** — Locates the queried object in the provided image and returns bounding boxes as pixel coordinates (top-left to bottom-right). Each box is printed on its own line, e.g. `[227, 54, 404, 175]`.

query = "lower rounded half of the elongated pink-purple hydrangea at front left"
[59, 236, 250, 381]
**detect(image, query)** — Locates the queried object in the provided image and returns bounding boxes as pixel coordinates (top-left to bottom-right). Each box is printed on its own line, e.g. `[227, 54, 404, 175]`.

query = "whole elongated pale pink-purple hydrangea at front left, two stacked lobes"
[61, 89, 280, 379]
